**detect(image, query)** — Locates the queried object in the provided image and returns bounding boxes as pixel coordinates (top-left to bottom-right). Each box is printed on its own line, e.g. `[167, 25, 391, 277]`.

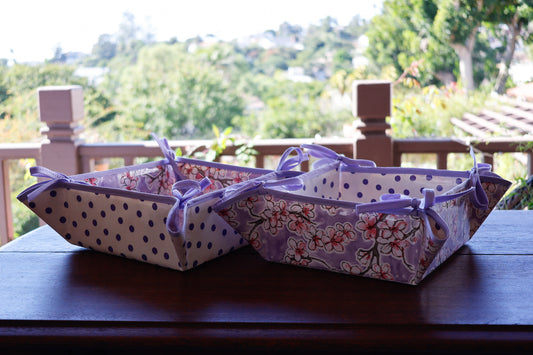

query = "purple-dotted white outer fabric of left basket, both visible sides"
[23, 181, 249, 269]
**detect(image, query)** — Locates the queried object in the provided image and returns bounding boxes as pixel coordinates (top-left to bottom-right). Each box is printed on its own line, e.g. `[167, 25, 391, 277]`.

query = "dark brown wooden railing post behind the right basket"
[352, 80, 393, 166]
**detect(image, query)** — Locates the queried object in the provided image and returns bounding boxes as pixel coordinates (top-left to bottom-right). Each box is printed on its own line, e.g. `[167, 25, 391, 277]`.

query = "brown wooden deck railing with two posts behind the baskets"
[0, 82, 533, 245]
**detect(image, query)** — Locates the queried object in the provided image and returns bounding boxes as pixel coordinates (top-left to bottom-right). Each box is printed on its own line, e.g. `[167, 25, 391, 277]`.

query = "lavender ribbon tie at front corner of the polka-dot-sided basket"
[167, 178, 212, 233]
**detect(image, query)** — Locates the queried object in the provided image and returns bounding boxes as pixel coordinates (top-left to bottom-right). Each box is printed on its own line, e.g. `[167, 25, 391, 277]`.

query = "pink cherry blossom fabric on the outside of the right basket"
[219, 175, 508, 285]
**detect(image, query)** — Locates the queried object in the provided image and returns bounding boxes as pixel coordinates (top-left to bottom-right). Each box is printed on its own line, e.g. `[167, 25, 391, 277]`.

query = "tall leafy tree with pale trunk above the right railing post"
[367, 0, 529, 91]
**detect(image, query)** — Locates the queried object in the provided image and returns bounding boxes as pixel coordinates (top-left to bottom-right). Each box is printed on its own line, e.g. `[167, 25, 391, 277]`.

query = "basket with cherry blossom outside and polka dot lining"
[215, 145, 510, 285]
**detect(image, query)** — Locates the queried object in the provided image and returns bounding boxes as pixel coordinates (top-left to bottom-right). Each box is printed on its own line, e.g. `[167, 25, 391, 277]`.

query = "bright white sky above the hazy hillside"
[0, 0, 383, 62]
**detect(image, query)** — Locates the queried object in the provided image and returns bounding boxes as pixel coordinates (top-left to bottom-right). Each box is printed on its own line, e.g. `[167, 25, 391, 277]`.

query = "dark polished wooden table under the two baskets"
[0, 211, 533, 354]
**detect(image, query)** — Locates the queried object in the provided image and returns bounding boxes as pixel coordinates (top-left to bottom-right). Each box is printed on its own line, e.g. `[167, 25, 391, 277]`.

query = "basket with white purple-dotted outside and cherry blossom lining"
[18, 136, 307, 271]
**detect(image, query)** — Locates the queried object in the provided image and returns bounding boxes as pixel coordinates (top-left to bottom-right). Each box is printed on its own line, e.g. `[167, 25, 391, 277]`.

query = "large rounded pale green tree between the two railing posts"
[105, 43, 244, 139]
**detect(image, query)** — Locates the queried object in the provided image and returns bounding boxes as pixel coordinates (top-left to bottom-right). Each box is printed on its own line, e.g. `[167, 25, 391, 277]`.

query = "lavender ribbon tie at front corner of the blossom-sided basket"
[356, 189, 448, 243]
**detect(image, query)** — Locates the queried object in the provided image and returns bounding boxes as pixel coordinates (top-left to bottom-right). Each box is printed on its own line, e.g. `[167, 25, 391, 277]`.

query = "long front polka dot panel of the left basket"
[23, 187, 179, 268]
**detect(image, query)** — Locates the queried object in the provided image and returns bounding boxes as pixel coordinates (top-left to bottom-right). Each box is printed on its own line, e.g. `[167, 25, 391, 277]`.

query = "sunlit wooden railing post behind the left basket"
[37, 85, 84, 175]
